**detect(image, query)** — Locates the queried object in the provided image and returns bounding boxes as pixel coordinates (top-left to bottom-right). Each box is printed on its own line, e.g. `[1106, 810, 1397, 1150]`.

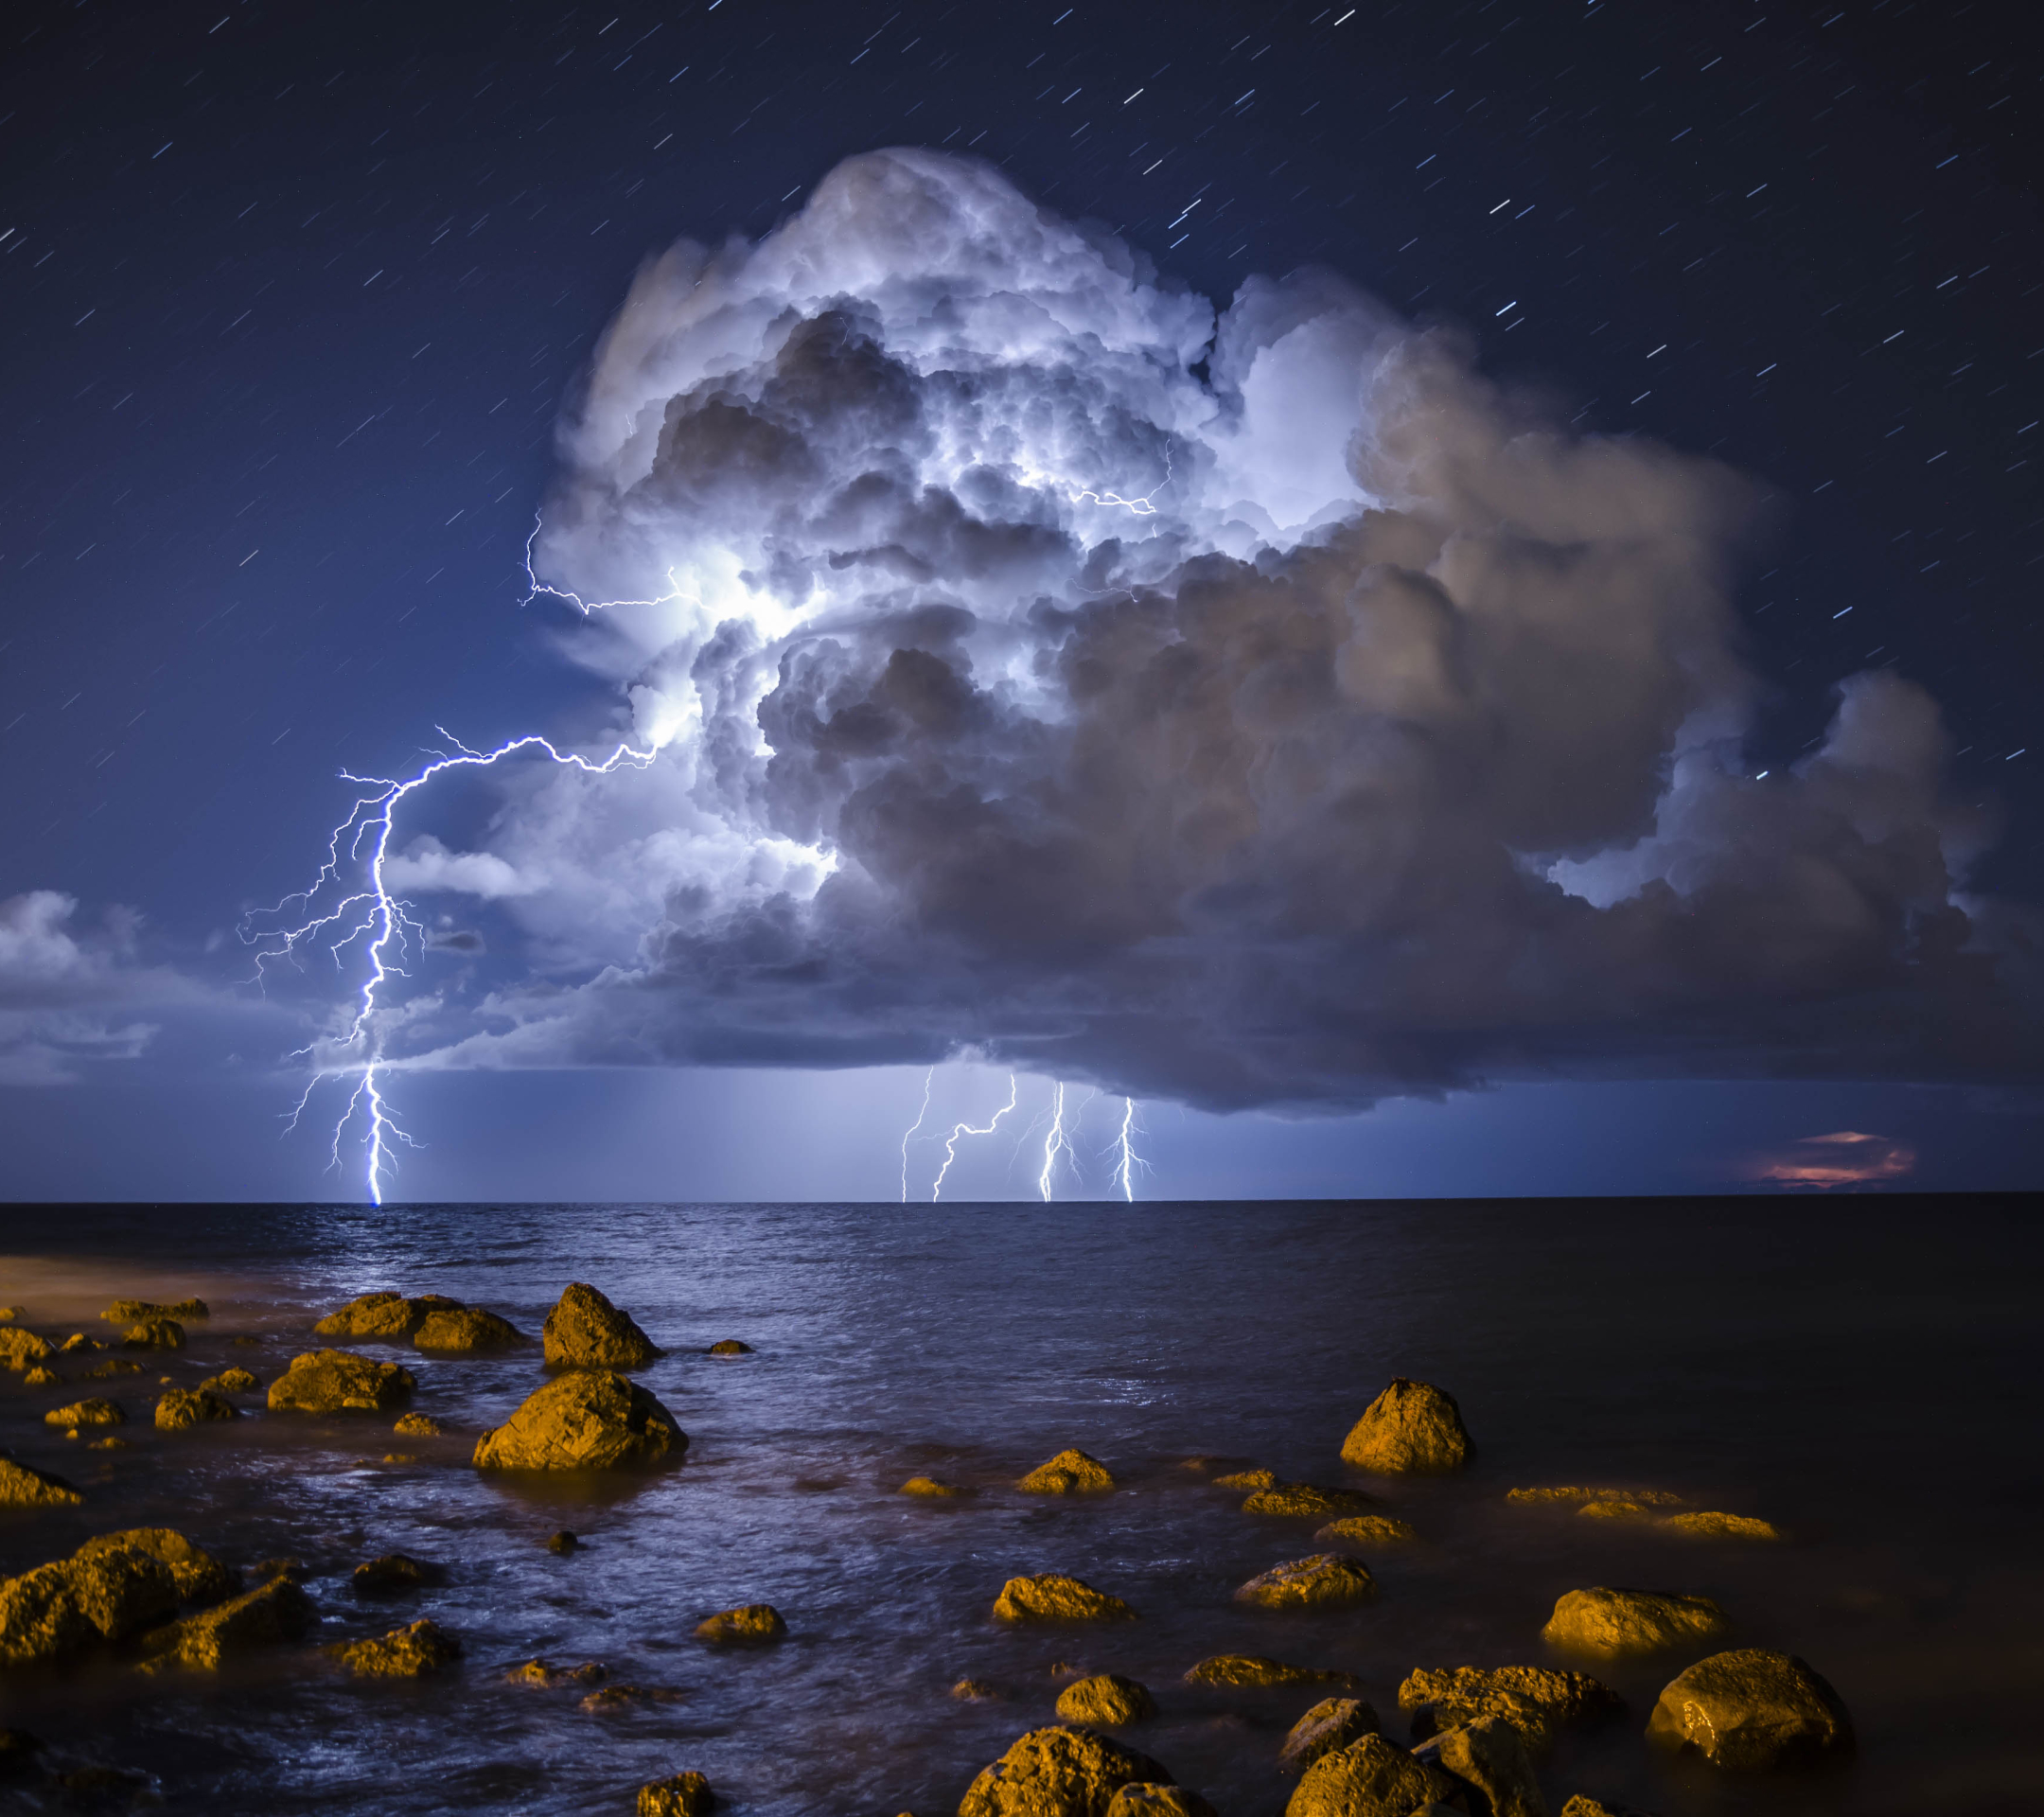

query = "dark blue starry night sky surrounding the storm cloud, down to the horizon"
[0, 0, 2044, 1200]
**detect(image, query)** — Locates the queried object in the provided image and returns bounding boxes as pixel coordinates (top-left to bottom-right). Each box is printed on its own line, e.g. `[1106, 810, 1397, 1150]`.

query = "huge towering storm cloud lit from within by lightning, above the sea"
[379, 151, 2035, 1108]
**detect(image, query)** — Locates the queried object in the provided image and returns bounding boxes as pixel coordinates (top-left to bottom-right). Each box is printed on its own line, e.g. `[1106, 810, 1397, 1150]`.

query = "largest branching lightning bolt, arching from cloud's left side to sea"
[243, 728, 654, 1206]
